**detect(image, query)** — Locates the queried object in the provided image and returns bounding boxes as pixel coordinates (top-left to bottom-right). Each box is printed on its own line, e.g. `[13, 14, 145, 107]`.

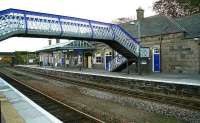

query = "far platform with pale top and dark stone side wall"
[16, 65, 200, 99]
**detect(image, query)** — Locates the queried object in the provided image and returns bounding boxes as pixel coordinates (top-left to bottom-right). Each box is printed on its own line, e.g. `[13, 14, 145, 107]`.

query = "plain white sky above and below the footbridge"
[0, 0, 156, 52]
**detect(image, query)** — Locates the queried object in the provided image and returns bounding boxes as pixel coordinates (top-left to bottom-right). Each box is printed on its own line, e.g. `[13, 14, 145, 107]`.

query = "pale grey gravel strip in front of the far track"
[80, 87, 200, 123]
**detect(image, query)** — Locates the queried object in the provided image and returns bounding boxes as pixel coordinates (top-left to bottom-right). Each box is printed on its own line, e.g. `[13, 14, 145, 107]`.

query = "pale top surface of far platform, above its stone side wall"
[18, 65, 200, 86]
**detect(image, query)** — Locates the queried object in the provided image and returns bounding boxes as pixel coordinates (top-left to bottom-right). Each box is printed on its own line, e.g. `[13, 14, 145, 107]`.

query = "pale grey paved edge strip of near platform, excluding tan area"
[0, 77, 62, 123]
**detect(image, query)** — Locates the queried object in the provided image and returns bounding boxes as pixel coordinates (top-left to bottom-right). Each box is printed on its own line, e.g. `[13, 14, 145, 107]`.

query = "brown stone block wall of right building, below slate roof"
[142, 33, 200, 73]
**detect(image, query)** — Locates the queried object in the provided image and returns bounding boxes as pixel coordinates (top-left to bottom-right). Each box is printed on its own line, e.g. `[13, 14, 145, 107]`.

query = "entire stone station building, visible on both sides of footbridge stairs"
[40, 8, 200, 74]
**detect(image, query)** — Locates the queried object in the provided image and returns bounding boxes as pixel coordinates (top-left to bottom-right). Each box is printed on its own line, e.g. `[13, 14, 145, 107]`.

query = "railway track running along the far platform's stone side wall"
[14, 67, 200, 111]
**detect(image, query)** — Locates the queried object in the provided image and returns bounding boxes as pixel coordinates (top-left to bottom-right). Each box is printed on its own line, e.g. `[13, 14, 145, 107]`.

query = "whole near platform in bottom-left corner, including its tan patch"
[0, 78, 62, 123]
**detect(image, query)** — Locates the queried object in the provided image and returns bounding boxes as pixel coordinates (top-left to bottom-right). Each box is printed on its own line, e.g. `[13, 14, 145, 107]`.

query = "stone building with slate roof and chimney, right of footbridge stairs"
[121, 8, 200, 73]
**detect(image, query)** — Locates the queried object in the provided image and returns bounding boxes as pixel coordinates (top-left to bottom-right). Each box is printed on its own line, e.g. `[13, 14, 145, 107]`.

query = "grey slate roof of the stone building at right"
[121, 14, 200, 38]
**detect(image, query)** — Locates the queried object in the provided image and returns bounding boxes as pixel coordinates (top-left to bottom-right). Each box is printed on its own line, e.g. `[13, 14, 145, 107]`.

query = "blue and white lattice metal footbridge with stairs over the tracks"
[0, 9, 147, 71]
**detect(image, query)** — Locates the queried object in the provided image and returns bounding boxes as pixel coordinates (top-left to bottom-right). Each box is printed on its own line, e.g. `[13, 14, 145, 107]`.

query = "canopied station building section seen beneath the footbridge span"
[37, 39, 114, 70]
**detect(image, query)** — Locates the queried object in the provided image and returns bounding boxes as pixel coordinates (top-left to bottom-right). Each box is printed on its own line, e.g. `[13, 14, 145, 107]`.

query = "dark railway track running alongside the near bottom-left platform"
[0, 72, 104, 123]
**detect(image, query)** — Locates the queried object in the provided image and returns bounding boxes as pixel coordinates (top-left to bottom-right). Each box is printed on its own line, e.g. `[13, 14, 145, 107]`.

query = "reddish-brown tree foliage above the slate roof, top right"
[153, 0, 200, 17]
